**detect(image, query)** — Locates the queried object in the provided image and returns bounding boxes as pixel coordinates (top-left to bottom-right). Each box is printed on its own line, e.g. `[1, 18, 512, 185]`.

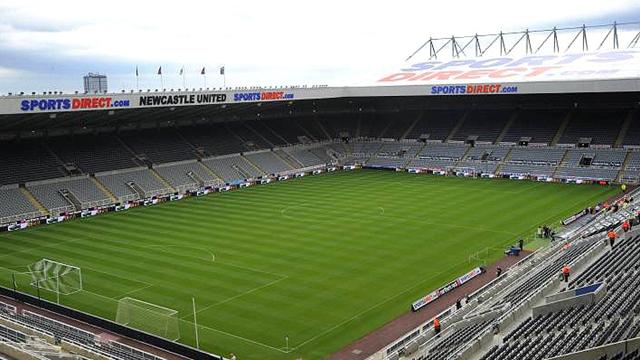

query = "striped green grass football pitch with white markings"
[0, 170, 617, 359]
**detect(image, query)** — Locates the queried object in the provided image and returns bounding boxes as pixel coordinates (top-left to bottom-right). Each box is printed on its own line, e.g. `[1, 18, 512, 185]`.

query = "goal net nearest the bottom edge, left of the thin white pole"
[116, 297, 180, 341]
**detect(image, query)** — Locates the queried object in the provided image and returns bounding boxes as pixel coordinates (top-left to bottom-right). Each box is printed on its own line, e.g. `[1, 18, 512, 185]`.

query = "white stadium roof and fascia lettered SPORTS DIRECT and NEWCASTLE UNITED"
[0, 49, 640, 114]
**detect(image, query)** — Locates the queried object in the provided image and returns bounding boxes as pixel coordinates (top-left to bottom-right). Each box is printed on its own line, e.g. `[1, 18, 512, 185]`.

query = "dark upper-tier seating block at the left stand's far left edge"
[0, 142, 65, 185]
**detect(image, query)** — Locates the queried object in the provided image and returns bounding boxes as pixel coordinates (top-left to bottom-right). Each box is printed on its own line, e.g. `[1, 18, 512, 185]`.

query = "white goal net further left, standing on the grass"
[28, 259, 82, 295]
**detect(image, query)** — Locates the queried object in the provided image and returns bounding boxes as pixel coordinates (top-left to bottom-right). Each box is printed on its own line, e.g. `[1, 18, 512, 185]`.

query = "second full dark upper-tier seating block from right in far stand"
[502, 109, 567, 144]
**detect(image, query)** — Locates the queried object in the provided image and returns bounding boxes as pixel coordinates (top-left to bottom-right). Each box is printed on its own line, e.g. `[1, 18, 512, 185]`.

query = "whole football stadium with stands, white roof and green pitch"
[0, 9, 640, 360]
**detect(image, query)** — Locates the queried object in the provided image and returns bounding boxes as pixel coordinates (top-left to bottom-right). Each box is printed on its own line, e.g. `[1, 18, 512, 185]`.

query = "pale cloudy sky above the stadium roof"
[0, 0, 640, 94]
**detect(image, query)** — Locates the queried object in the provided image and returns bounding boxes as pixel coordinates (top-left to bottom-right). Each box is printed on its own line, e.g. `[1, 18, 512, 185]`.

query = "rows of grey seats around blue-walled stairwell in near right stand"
[482, 236, 640, 360]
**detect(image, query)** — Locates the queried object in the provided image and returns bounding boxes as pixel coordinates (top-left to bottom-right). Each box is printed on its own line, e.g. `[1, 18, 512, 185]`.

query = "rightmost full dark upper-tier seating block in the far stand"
[559, 109, 627, 145]
